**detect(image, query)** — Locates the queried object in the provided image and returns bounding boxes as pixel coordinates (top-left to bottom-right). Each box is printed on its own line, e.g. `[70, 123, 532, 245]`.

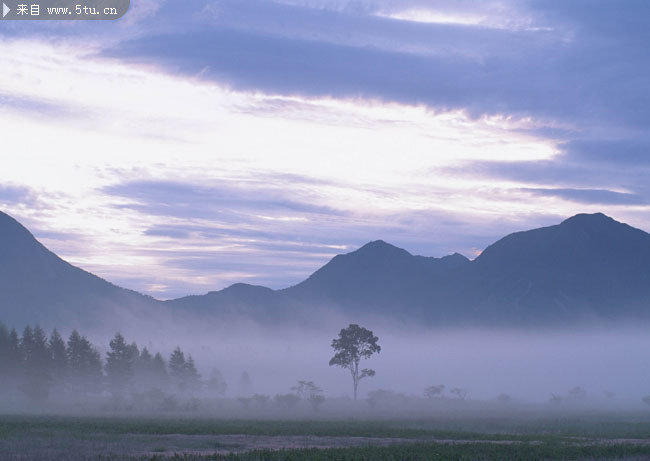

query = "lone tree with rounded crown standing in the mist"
[330, 323, 381, 400]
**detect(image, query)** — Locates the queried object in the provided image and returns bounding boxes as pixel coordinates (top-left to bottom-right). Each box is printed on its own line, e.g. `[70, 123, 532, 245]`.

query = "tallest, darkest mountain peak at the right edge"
[455, 213, 650, 321]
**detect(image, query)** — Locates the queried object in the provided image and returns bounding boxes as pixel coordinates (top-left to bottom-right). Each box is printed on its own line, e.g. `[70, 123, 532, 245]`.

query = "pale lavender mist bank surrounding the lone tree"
[104, 321, 650, 405]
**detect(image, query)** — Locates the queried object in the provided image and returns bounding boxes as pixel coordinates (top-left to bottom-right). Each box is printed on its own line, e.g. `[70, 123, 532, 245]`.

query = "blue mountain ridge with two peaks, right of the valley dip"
[163, 213, 650, 325]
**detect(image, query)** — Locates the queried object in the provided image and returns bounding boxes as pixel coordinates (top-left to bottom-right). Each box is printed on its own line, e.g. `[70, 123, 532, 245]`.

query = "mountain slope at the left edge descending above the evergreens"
[0, 212, 156, 326]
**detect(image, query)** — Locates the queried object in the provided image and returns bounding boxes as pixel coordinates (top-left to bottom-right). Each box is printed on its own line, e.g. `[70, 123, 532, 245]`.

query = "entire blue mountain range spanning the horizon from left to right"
[0, 209, 650, 326]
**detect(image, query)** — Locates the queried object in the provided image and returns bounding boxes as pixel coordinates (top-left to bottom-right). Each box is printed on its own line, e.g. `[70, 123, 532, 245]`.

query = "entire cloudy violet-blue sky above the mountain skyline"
[0, 0, 650, 299]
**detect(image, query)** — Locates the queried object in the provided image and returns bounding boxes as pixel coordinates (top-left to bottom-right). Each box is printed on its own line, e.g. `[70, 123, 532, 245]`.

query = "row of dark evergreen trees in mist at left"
[0, 323, 201, 401]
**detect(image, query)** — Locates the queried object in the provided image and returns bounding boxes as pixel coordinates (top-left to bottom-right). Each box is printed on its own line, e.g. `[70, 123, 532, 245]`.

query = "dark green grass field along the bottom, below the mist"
[0, 414, 650, 460]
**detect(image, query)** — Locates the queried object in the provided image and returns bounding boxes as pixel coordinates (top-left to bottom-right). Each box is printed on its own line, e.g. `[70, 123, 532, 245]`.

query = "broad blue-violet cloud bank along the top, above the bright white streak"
[98, 1, 650, 131]
